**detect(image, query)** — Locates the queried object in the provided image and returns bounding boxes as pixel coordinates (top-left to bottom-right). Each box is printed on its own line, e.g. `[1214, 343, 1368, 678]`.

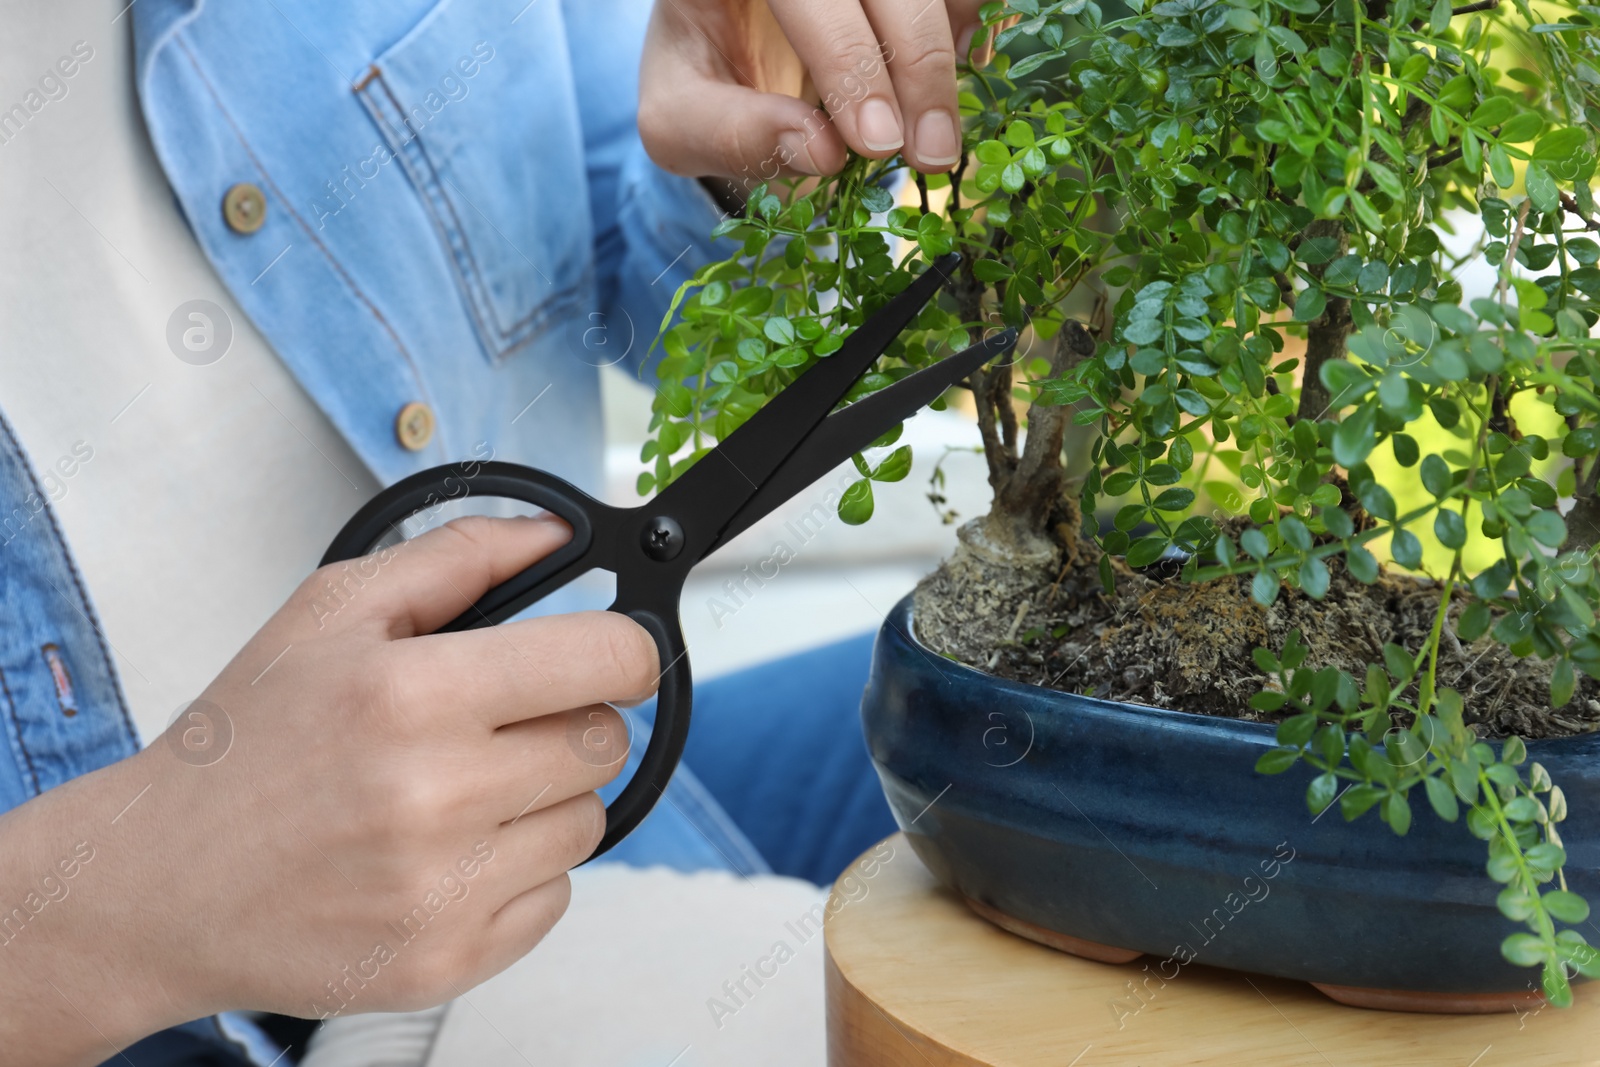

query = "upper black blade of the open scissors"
[656, 253, 960, 545]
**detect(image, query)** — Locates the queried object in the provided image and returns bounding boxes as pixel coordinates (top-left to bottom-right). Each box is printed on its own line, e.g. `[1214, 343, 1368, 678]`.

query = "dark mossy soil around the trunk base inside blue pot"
[915, 525, 1600, 739]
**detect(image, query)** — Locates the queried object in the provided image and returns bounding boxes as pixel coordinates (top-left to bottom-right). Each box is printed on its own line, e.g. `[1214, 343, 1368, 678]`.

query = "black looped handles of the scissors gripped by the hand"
[322, 461, 693, 862]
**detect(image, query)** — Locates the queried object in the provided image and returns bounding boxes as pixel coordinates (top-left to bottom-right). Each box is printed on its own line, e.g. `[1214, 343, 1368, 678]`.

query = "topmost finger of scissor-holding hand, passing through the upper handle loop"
[299, 515, 573, 638]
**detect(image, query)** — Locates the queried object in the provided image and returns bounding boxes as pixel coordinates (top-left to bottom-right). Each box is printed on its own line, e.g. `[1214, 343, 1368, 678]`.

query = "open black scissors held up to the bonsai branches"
[322, 253, 1018, 862]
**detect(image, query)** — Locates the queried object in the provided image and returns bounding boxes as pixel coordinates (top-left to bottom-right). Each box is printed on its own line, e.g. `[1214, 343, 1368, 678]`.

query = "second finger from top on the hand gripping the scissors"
[392, 611, 661, 728]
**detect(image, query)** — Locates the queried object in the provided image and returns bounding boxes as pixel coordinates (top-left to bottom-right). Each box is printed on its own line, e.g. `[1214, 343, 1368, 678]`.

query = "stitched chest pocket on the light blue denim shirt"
[357, 0, 592, 360]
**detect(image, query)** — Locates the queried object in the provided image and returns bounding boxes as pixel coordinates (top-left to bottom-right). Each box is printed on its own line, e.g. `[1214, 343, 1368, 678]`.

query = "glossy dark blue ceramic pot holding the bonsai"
[862, 597, 1600, 1009]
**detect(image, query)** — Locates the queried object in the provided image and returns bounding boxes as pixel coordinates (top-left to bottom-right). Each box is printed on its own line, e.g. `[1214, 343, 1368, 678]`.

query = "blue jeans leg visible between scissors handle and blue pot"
[602, 633, 894, 885]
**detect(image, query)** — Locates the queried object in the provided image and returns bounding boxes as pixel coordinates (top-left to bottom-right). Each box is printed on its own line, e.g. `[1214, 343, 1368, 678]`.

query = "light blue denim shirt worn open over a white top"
[0, 0, 736, 1067]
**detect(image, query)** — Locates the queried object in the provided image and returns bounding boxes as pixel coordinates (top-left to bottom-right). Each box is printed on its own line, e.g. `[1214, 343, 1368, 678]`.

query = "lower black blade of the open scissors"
[701, 330, 1018, 558]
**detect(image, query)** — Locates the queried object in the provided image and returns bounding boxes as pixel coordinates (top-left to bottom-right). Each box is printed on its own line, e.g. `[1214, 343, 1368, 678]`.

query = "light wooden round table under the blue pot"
[826, 833, 1600, 1067]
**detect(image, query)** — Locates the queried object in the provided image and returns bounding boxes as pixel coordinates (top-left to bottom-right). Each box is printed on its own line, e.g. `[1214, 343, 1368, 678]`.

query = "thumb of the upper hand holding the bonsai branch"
[638, 69, 846, 181]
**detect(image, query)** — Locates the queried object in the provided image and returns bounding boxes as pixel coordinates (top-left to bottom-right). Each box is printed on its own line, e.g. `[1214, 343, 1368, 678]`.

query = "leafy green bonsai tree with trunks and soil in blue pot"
[638, 0, 1600, 1005]
